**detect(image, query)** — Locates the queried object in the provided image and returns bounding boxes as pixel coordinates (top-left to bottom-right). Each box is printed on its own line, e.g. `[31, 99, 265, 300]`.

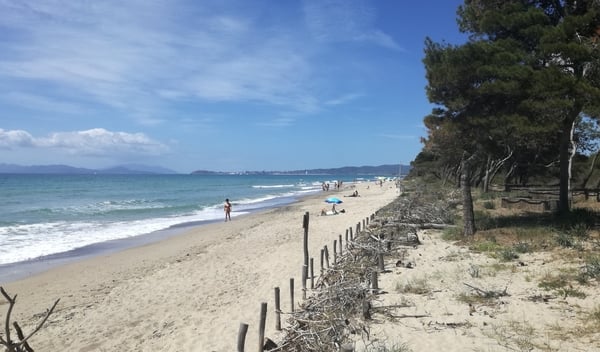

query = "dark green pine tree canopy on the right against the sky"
[415, 0, 600, 236]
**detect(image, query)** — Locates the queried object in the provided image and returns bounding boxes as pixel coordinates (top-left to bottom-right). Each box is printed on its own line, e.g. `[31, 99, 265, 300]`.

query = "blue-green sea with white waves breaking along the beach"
[0, 174, 368, 283]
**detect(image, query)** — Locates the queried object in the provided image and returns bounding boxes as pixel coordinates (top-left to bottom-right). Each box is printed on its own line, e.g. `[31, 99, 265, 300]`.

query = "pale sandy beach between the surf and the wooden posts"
[0, 182, 398, 352]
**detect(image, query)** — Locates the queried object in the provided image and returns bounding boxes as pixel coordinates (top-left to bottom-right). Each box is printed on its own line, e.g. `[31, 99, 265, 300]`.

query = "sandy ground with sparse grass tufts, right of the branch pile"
[355, 230, 600, 352]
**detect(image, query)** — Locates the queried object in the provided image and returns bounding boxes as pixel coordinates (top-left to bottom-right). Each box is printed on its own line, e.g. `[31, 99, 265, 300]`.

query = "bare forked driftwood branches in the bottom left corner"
[0, 286, 60, 352]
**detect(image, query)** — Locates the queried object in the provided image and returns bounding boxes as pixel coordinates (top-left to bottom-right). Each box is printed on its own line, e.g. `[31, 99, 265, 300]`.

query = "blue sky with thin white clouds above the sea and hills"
[0, 0, 465, 173]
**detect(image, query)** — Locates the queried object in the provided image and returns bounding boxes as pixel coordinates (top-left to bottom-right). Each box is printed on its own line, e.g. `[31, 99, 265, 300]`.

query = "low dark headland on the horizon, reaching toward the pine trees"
[192, 164, 410, 176]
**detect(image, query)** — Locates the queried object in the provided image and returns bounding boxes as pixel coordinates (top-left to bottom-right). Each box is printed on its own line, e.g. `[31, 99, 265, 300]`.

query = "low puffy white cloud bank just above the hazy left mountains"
[0, 128, 169, 157]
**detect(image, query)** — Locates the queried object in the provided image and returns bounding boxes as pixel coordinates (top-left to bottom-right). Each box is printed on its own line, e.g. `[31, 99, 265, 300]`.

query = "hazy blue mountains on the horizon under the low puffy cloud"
[0, 163, 177, 175]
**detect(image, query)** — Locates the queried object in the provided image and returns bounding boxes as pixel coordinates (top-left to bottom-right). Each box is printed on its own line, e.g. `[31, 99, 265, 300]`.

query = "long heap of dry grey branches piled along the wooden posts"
[270, 186, 450, 352]
